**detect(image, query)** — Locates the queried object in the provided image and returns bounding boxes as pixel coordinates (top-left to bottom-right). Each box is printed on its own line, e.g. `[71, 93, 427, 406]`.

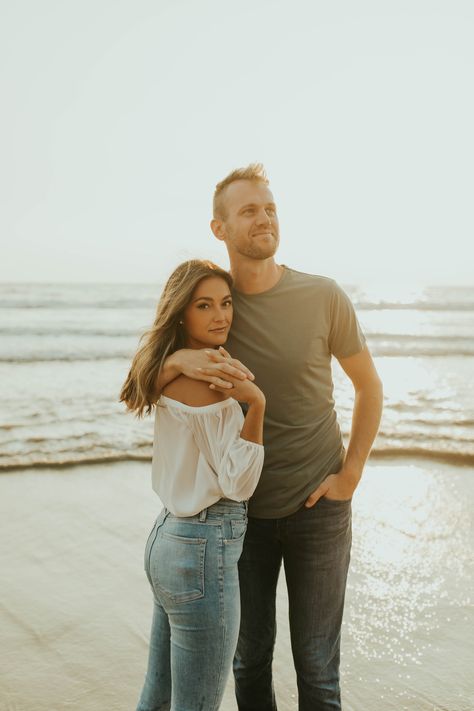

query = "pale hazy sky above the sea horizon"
[0, 0, 474, 285]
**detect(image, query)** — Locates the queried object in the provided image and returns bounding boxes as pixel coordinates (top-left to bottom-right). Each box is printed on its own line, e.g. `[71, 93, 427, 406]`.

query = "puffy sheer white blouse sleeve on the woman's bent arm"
[181, 407, 264, 501]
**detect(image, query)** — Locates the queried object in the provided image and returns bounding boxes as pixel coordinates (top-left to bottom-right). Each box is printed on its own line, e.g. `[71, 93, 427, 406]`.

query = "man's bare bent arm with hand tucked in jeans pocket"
[305, 347, 383, 507]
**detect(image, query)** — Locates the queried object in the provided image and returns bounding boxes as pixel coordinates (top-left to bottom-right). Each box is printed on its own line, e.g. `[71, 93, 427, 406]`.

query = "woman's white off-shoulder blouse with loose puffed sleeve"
[152, 395, 264, 516]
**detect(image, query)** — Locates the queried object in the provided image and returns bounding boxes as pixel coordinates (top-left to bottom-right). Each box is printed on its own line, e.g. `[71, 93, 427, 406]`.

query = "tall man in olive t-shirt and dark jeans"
[158, 164, 382, 711]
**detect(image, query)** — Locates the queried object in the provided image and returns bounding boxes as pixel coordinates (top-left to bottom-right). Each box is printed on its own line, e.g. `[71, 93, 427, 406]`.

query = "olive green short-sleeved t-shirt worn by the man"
[226, 267, 365, 518]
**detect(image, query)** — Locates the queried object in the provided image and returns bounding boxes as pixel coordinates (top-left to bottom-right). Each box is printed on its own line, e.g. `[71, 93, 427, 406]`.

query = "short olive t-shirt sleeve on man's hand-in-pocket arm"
[328, 282, 366, 358]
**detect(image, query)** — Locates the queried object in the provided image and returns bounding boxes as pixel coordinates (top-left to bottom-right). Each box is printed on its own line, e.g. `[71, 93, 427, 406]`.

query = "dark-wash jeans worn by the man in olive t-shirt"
[234, 498, 351, 711]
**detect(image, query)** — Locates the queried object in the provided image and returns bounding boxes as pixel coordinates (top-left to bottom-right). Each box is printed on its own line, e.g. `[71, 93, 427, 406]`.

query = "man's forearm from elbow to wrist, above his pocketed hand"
[343, 380, 383, 484]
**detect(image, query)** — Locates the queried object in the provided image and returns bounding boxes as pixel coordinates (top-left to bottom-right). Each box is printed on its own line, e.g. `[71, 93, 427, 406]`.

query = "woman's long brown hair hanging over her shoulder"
[120, 259, 232, 417]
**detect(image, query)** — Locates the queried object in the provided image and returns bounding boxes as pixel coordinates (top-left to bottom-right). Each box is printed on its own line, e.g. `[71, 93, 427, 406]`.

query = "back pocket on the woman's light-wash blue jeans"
[150, 531, 207, 603]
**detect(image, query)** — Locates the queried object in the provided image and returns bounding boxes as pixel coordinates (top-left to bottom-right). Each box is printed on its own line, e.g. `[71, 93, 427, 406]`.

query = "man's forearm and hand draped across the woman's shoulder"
[155, 347, 255, 398]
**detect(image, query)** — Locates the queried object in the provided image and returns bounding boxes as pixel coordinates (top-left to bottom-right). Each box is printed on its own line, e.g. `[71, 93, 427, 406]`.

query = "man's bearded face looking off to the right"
[219, 180, 280, 259]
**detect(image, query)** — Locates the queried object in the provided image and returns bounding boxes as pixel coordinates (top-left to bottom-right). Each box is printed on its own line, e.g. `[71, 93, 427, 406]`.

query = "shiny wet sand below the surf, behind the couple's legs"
[0, 459, 474, 711]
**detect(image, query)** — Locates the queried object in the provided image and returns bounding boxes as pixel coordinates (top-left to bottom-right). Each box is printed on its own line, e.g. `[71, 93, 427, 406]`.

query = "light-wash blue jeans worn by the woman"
[137, 500, 247, 711]
